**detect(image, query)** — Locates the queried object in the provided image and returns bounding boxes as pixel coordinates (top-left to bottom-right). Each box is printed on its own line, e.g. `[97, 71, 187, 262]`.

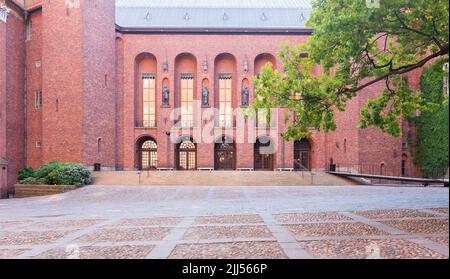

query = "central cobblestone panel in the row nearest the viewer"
[169, 242, 287, 259]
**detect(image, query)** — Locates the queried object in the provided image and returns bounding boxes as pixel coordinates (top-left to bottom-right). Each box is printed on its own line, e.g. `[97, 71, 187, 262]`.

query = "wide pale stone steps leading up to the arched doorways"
[94, 171, 356, 186]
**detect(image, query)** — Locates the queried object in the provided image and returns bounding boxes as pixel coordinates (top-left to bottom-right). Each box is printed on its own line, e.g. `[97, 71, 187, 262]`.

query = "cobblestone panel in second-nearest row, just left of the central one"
[76, 227, 170, 242]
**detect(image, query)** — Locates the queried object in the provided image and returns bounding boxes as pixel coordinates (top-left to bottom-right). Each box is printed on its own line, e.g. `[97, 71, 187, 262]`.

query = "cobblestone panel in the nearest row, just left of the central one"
[36, 245, 154, 259]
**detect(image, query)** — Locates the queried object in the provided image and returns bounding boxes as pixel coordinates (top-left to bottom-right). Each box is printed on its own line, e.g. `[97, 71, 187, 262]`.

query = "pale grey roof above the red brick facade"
[116, 0, 311, 30]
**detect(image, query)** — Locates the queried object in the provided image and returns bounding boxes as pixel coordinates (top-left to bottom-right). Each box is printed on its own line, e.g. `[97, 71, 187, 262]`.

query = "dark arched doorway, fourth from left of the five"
[254, 137, 275, 171]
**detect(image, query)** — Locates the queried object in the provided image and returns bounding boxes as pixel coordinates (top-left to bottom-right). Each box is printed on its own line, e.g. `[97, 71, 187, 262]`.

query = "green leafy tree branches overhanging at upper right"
[253, 0, 449, 139]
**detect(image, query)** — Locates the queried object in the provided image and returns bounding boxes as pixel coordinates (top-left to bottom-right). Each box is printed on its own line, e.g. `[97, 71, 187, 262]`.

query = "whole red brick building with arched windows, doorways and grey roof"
[0, 0, 419, 197]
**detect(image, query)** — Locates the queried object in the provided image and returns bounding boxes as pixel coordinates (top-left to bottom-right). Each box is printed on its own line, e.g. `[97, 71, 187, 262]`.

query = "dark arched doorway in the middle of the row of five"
[214, 137, 236, 170]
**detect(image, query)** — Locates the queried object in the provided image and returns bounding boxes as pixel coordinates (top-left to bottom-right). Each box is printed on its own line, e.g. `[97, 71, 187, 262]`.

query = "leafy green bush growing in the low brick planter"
[18, 161, 92, 186]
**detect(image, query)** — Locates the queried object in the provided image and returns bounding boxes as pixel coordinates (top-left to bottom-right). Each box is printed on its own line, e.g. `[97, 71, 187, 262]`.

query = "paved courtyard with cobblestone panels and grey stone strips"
[0, 186, 449, 259]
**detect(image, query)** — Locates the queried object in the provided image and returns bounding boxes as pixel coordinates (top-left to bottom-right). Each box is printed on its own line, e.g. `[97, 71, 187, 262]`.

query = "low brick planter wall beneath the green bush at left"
[14, 184, 77, 198]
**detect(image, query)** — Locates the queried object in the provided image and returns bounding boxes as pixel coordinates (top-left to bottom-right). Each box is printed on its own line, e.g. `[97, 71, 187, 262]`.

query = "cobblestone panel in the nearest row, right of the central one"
[300, 239, 446, 259]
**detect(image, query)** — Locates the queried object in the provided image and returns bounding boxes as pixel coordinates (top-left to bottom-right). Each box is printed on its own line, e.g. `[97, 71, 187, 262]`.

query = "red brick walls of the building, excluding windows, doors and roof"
[0, 0, 418, 196]
